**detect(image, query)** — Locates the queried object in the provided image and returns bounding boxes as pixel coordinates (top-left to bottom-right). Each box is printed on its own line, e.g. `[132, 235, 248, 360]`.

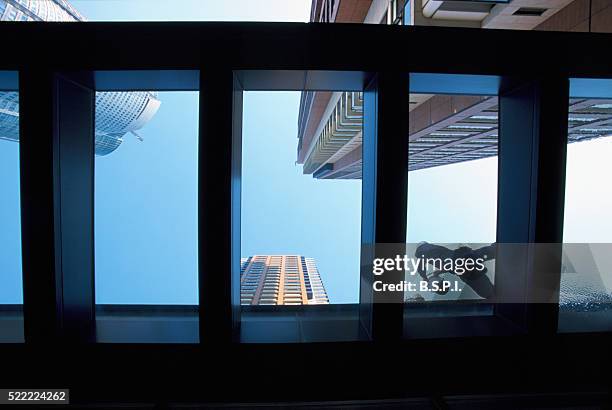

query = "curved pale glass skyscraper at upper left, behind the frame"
[0, 0, 161, 155]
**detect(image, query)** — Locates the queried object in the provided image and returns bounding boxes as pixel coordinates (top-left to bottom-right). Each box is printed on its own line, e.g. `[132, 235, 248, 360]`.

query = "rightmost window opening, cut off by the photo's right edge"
[559, 88, 612, 332]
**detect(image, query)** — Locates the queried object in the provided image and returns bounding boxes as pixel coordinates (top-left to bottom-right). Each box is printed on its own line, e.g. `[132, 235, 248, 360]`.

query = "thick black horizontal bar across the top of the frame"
[0, 22, 612, 78]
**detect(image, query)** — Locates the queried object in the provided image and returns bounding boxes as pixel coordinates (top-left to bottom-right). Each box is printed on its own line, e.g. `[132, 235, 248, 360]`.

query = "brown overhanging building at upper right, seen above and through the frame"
[297, 0, 612, 179]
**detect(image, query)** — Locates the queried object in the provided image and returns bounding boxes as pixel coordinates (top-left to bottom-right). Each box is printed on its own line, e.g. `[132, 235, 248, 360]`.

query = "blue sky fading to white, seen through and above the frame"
[0, 0, 612, 304]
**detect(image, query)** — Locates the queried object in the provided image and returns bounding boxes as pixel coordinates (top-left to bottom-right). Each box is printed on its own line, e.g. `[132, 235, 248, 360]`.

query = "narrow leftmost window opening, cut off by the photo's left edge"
[0, 86, 23, 342]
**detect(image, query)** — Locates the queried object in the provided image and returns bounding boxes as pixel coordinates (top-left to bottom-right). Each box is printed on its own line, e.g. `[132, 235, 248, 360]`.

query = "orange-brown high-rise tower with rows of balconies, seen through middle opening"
[240, 255, 329, 305]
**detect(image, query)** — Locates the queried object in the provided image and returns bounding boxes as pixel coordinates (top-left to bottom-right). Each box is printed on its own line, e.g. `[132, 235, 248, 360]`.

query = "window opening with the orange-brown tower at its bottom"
[241, 92, 363, 342]
